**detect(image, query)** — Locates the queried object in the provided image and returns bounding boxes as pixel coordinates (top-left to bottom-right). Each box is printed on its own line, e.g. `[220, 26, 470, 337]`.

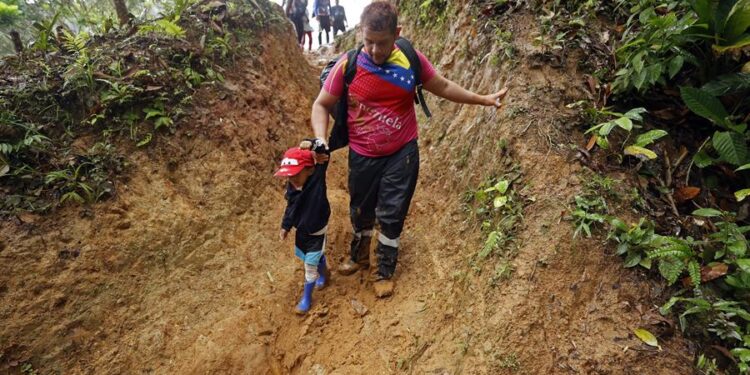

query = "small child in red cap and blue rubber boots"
[274, 141, 331, 315]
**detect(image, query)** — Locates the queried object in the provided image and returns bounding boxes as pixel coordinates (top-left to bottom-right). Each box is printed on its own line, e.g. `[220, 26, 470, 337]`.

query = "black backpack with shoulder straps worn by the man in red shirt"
[320, 37, 432, 151]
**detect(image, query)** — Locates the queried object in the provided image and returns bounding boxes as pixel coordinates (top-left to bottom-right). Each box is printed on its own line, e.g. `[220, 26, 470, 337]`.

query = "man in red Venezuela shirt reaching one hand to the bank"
[311, 1, 507, 298]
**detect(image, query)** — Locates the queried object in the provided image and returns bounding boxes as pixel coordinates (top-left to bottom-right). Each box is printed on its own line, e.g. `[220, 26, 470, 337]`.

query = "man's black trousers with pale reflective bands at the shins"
[349, 139, 419, 279]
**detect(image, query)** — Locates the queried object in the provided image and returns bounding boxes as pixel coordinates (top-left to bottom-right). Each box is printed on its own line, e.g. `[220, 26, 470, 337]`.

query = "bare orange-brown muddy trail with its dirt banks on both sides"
[0, 1, 692, 374]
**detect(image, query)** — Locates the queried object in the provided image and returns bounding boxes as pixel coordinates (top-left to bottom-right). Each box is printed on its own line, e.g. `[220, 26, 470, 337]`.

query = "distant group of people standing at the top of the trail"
[285, 0, 349, 51]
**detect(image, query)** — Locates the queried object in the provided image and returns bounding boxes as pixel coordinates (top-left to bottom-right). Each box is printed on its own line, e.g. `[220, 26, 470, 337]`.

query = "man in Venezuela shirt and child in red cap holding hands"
[276, 0, 508, 314]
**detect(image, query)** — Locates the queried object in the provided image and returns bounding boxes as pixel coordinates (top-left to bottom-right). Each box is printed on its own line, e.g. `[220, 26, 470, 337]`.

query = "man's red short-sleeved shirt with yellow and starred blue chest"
[323, 46, 435, 157]
